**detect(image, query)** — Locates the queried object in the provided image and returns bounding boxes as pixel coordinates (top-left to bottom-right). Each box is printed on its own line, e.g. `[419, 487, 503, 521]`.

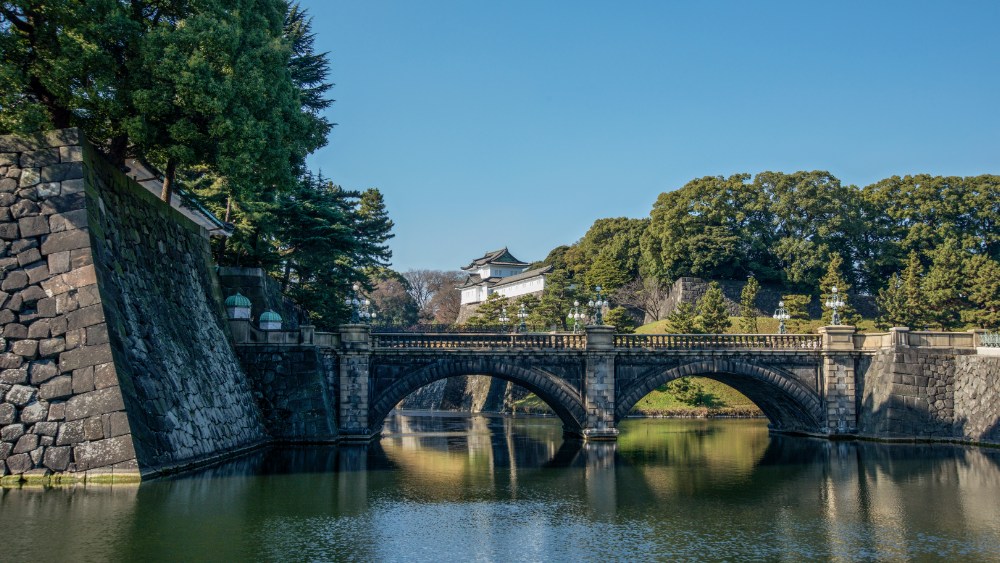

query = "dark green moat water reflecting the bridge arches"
[0, 416, 1000, 561]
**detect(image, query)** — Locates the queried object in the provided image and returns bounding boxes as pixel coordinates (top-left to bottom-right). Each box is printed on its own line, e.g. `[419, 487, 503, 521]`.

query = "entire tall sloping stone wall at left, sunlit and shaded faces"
[0, 129, 265, 481]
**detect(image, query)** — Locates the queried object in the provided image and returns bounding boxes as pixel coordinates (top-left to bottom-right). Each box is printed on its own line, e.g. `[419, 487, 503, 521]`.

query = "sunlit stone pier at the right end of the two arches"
[819, 326, 858, 435]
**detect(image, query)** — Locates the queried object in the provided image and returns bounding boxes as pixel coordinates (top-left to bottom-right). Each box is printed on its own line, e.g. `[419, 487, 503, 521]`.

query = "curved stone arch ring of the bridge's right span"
[615, 359, 826, 433]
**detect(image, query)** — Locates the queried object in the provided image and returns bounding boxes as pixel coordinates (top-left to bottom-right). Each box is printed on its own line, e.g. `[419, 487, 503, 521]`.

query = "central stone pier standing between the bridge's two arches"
[583, 325, 618, 440]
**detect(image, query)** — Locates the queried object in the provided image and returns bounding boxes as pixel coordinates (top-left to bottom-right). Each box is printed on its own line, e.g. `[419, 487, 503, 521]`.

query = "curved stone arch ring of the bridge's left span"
[368, 357, 586, 434]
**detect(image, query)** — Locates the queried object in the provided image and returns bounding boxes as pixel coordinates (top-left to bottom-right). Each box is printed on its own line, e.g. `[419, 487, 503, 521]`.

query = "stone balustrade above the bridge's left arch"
[371, 333, 587, 350]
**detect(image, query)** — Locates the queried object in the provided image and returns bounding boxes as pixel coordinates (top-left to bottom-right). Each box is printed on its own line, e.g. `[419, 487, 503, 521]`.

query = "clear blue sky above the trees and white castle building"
[302, 0, 1000, 271]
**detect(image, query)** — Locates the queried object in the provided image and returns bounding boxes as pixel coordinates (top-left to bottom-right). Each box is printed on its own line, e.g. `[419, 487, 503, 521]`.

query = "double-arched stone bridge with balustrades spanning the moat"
[230, 319, 1000, 441]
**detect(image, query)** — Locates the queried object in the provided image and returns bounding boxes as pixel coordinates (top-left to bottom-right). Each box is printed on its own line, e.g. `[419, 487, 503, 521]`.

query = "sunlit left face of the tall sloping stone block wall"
[0, 130, 139, 481]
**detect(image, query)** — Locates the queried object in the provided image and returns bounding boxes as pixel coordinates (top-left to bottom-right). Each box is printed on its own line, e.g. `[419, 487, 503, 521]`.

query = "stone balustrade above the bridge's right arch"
[615, 334, 823, 350]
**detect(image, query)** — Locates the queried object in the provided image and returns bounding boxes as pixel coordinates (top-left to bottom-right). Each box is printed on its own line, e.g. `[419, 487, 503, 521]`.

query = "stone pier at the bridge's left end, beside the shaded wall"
[337, 325, 381, 442]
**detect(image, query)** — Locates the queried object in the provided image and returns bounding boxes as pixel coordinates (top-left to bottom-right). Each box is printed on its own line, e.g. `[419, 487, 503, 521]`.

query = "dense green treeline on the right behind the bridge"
[542, 171, 1000, 328]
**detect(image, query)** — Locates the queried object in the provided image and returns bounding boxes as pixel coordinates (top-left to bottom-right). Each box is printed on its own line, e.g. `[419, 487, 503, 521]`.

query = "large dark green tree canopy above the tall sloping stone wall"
[0, 0, 393, 326]
